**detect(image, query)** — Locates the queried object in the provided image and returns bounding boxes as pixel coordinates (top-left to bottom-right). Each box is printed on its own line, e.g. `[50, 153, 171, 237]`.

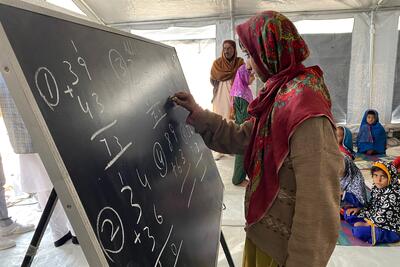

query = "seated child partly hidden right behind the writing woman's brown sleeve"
[336, 126, 367, 210]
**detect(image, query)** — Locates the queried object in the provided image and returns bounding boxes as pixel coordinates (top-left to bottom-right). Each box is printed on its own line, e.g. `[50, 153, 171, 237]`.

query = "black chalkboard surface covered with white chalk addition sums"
[0, 1, 223, 267]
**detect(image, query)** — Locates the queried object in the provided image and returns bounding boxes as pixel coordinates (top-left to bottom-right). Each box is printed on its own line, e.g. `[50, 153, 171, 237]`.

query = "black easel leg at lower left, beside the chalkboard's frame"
[21, 188, 58, 267]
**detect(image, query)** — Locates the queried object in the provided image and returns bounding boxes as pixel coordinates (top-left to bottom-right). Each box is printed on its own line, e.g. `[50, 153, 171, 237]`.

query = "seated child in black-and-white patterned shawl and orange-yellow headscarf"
[344, 161, 400, 245]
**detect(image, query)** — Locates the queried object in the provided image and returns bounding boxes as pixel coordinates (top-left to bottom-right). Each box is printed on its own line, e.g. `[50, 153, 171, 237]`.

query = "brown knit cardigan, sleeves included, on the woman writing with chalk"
[188, 111, 343, 267]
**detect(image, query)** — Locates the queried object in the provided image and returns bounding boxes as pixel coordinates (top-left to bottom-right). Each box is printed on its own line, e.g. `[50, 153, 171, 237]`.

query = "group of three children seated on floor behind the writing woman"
[337, 110, 400, 245]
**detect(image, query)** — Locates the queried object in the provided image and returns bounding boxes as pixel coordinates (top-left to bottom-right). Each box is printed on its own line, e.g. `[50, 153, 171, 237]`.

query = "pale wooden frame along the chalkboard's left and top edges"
[0, 0, 191, 266]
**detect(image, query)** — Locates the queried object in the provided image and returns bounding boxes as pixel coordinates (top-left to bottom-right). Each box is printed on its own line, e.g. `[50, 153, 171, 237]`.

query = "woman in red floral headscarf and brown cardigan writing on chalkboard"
[173, 11, 343, 267]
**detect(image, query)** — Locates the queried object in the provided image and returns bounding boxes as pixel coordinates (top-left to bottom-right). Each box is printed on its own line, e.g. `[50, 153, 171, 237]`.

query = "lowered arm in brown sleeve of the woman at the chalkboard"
[285, 117, 344, 267]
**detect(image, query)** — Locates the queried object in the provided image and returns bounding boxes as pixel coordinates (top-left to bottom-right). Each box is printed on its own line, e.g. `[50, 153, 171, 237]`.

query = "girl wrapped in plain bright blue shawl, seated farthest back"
[357, 109, 386, 155]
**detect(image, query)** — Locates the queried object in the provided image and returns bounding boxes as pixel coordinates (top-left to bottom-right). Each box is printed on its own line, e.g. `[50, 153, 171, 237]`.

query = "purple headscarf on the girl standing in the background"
[231, 64, 253, 104]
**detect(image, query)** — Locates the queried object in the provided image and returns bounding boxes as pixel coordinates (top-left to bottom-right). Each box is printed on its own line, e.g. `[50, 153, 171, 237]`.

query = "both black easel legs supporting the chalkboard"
[21, 188, 235, 267]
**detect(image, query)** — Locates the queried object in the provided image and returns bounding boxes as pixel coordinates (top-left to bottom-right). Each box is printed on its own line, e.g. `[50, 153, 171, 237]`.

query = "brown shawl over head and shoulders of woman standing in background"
[211, 40, 244, 81]
